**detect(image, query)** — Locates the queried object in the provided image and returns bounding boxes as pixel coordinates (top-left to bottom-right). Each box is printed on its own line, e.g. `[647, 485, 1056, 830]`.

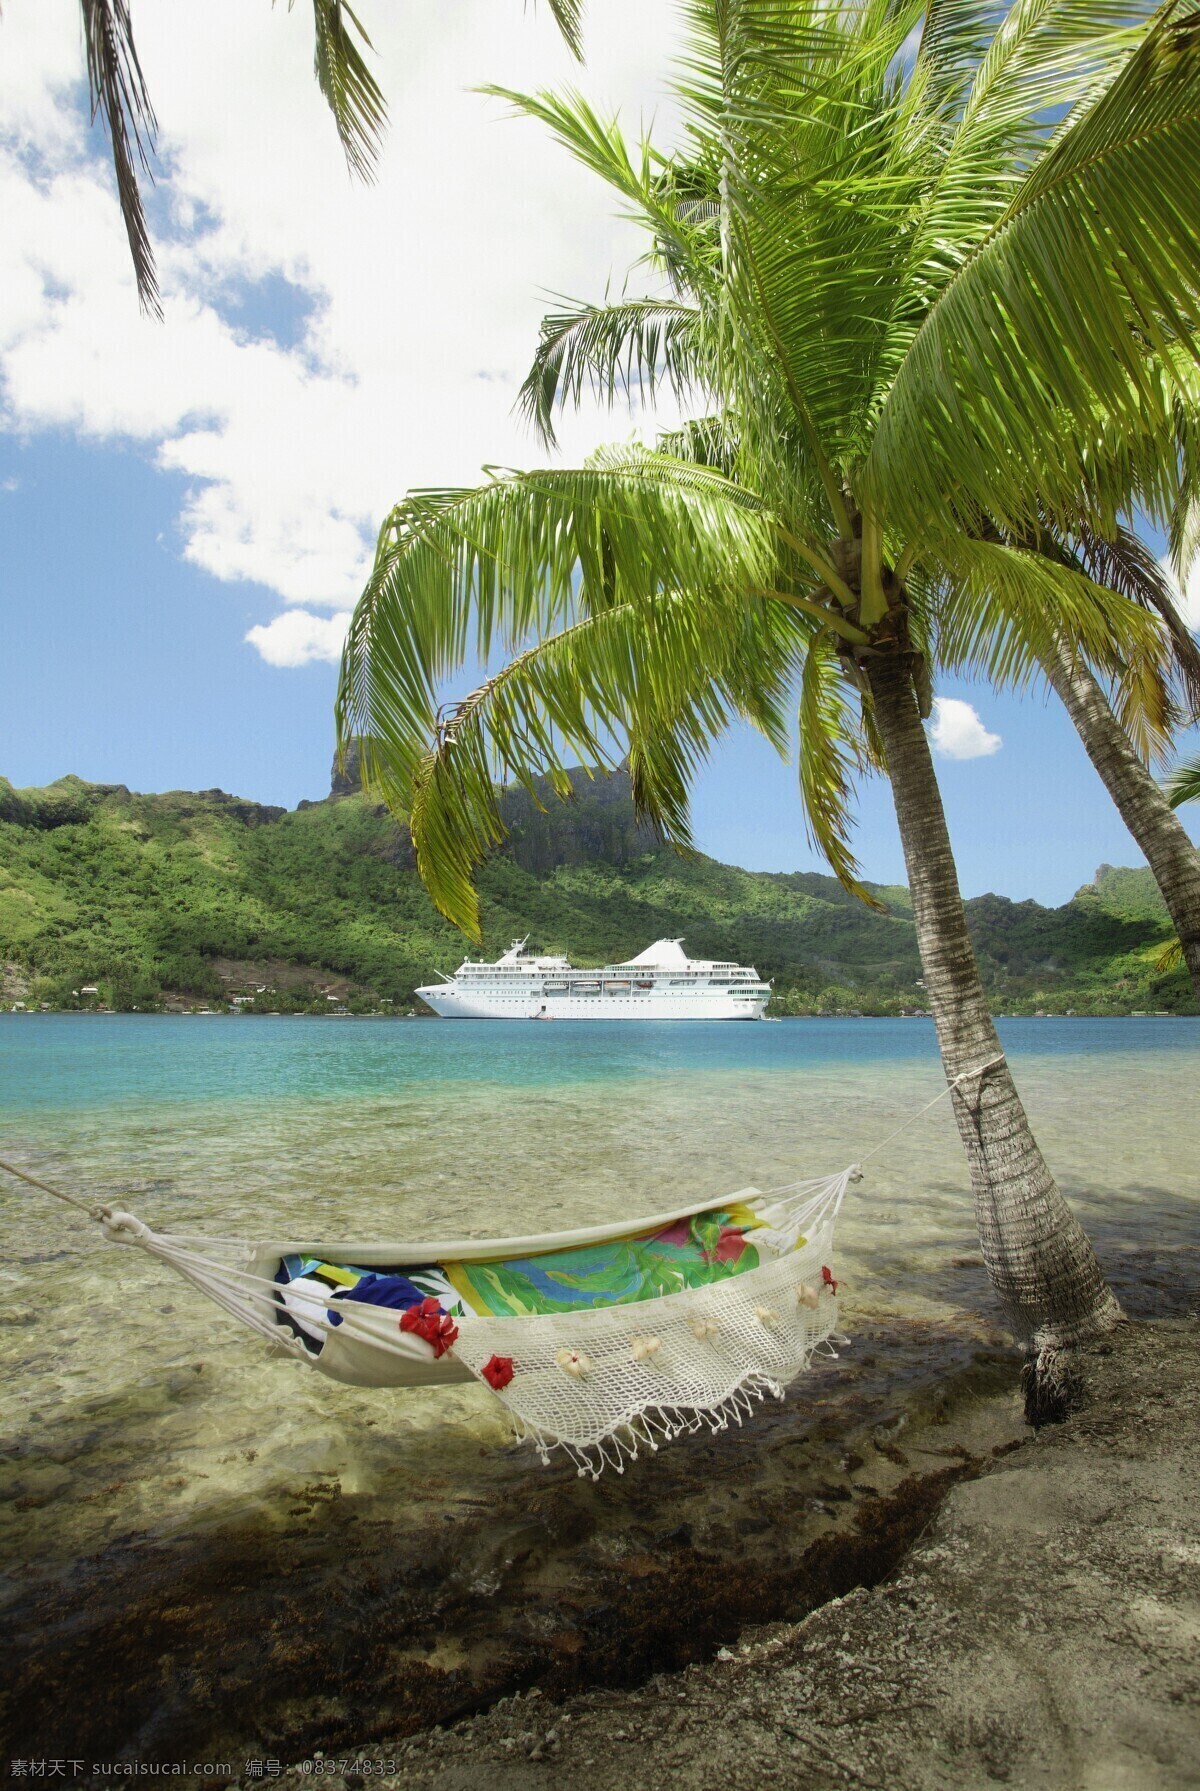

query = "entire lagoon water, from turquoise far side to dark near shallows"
[0, 1015, 1200, 1752]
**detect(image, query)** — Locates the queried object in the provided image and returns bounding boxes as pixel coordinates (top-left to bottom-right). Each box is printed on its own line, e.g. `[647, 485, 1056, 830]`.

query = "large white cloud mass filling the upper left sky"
[0, 0, 677, 630]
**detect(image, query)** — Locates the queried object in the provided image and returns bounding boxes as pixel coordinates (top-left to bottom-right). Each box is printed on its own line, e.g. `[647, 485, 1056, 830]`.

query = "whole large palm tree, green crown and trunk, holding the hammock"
[339, 0, 1200, 1382]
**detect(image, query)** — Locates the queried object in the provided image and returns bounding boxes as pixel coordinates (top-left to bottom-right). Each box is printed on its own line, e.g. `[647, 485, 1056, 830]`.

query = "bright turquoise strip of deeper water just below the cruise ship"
[0, 1014, 1200, 1114]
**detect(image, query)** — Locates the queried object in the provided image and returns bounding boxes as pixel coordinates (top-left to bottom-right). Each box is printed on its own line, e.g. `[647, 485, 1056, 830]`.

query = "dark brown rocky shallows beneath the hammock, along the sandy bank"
[0, 1311, 1024, 1778]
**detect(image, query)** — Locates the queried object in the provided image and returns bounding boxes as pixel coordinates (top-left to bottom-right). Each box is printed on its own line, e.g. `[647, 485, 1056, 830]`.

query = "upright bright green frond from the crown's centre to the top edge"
[681, 0, 924, 483]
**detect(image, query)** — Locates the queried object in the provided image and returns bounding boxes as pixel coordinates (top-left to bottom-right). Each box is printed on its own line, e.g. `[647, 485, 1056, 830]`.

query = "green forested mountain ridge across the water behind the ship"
[0, 772, 1195, 1014]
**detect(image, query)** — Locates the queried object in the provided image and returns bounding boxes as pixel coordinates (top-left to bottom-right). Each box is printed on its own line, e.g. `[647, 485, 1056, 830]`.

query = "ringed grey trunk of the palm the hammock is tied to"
[863, 654, 1121, 1356]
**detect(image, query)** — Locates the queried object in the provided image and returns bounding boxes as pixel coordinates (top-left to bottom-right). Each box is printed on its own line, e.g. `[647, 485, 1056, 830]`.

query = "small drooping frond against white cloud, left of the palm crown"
[518, 299, 704, 446]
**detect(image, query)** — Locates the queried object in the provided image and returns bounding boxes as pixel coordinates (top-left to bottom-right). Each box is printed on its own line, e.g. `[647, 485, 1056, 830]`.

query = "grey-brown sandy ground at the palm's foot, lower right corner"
[313, 1315, 1200, 1791]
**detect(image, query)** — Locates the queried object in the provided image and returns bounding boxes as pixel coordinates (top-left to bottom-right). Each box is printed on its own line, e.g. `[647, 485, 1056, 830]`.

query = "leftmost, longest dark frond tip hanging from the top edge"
[81, 0, 163, 319]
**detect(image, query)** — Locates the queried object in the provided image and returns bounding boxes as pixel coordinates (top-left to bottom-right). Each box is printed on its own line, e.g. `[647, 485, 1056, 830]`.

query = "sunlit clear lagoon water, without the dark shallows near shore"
[0, 1015, 1200, 1589]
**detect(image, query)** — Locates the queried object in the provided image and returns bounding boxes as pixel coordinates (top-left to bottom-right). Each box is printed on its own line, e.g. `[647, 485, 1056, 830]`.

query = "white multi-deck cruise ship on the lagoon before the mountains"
[417, 938, 770, 1019]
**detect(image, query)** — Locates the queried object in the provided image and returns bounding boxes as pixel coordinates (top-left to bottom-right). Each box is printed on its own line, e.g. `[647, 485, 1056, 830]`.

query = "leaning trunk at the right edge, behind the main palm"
[1044, 647, 1200, 996]
